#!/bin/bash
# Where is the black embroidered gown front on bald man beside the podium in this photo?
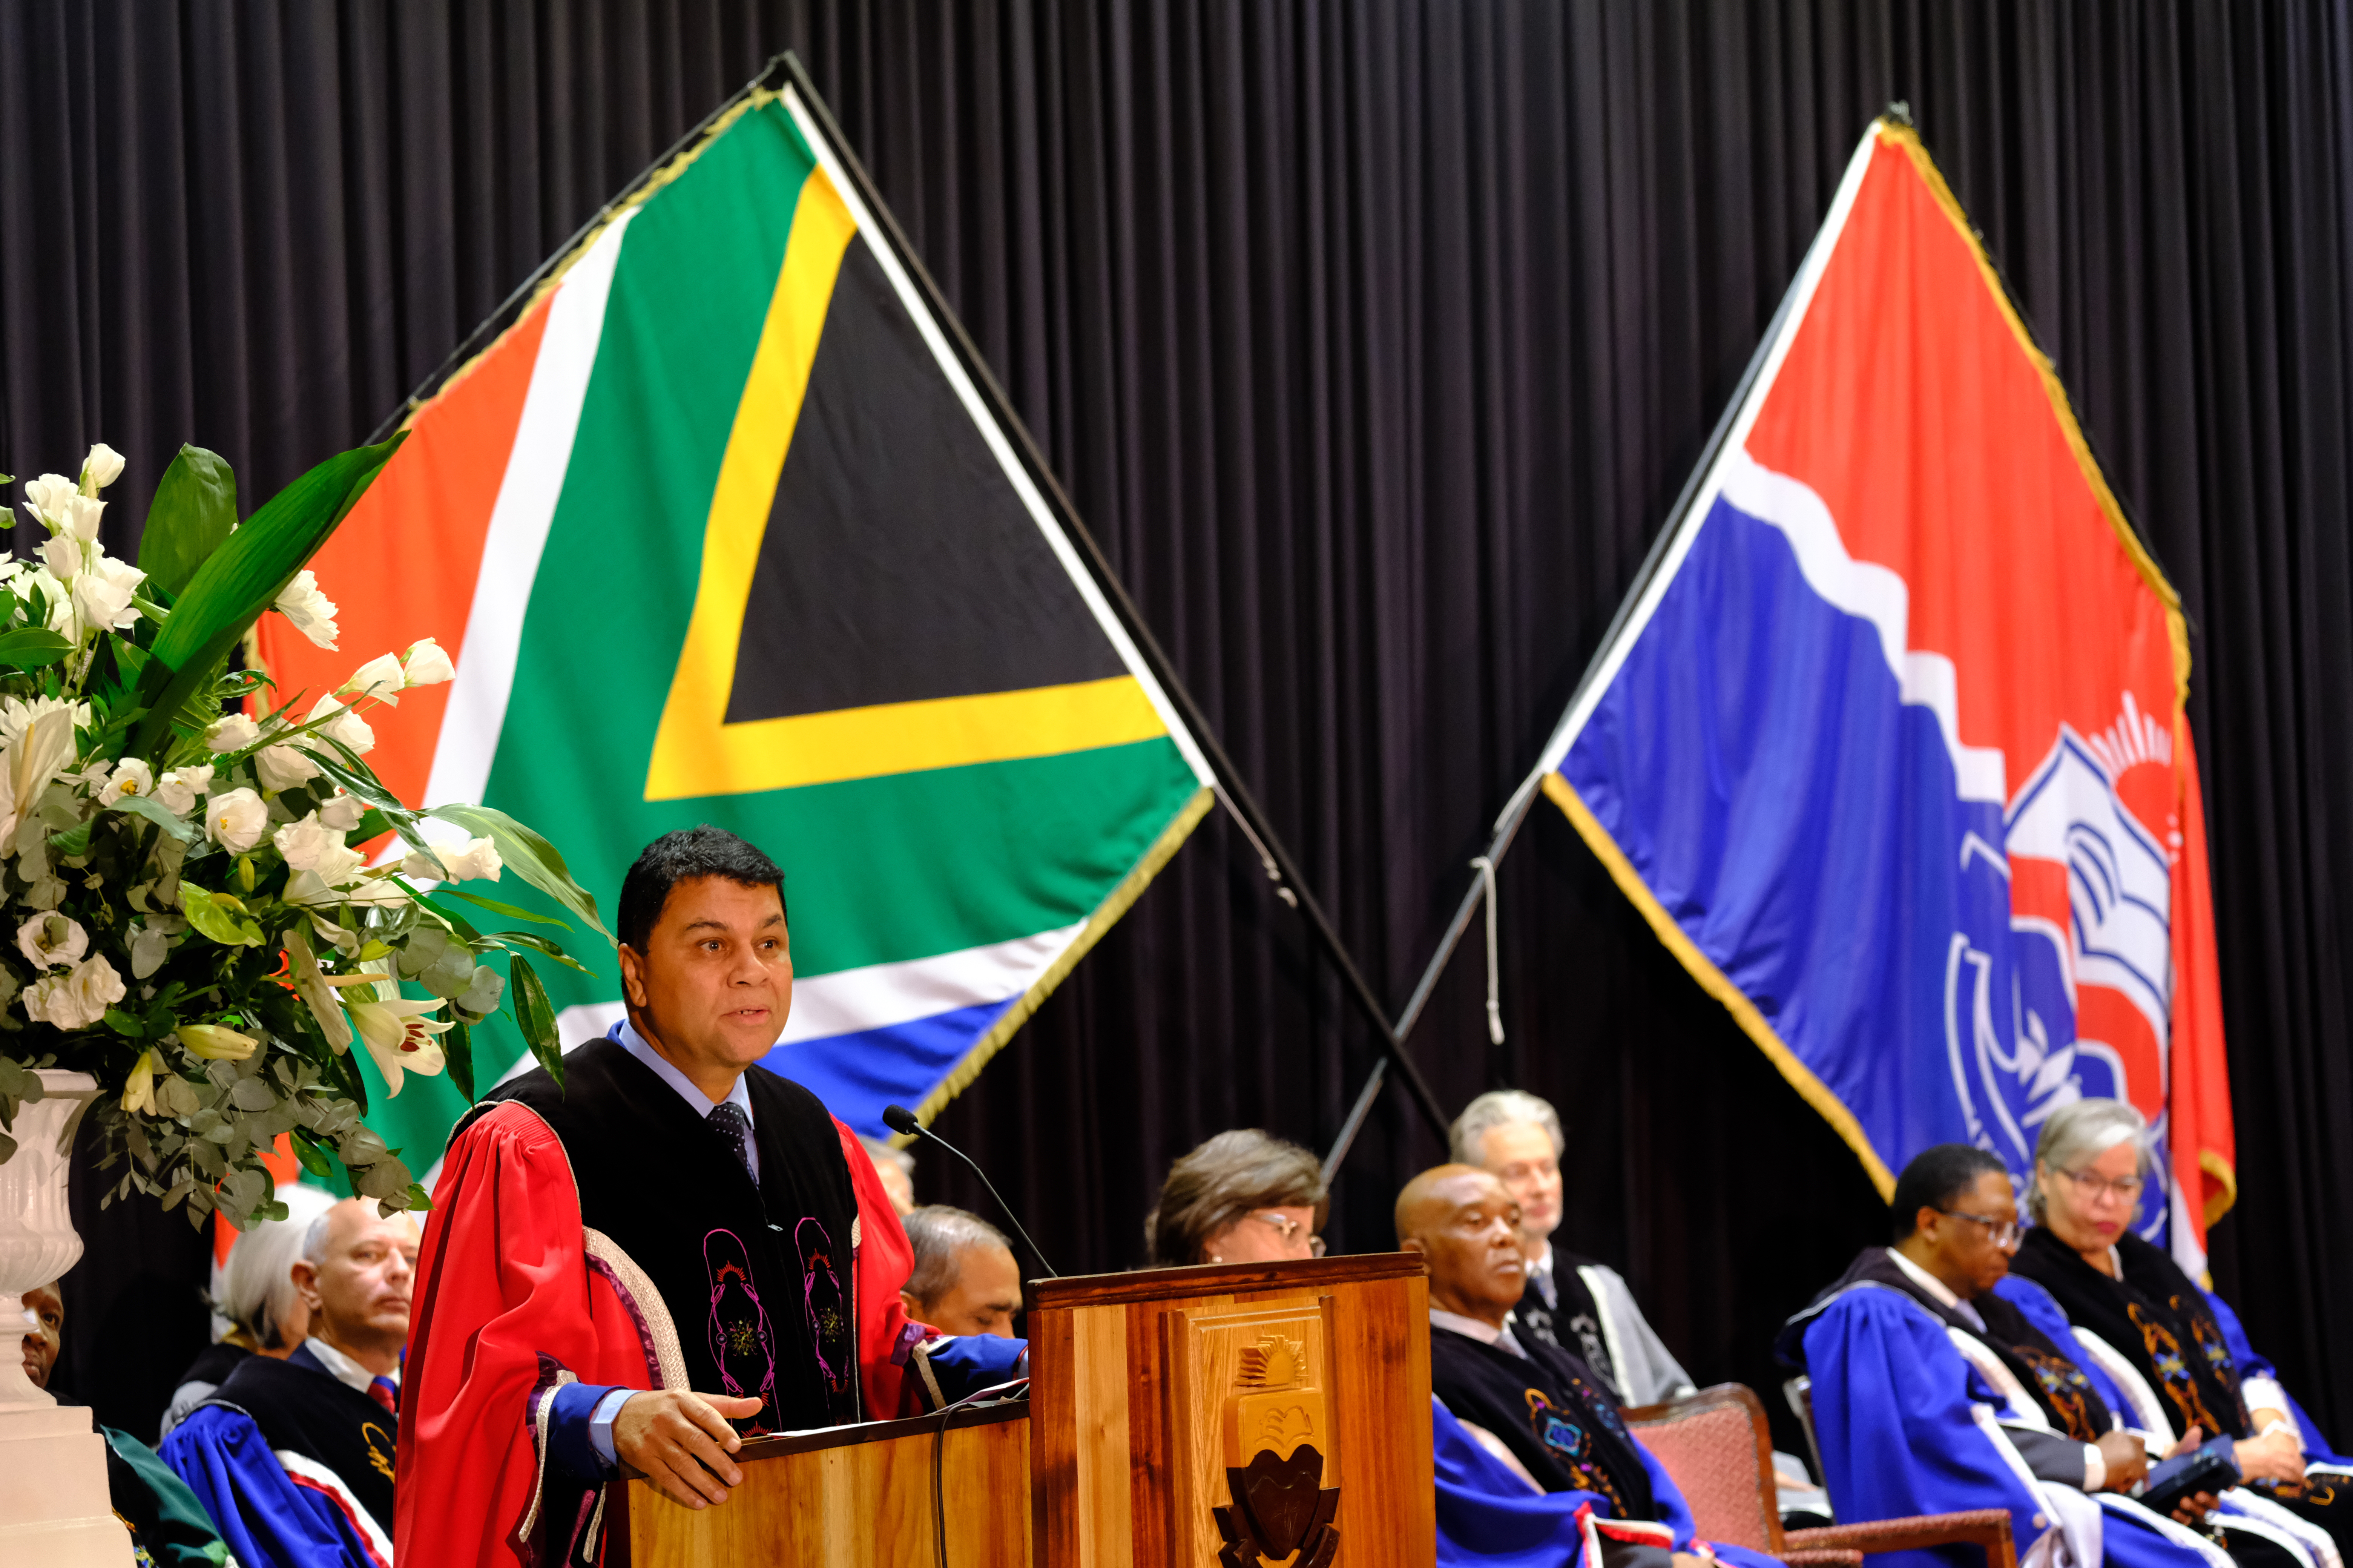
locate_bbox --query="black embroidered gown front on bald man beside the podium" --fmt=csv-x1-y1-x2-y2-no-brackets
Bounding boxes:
1431,1323,1659,1519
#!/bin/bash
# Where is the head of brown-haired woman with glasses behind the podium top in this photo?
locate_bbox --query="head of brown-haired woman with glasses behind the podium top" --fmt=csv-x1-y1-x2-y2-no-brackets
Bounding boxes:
1144,1128,1332,1269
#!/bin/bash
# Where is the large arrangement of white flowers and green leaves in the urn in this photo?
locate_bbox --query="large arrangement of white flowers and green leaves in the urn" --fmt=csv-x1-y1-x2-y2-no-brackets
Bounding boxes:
0,438,609,1227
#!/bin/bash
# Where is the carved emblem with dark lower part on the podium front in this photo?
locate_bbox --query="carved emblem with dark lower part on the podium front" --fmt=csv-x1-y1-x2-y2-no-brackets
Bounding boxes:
1212,1333,1339,1568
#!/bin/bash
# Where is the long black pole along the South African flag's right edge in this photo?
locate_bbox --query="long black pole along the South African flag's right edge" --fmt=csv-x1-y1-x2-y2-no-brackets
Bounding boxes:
772,49,1447,1140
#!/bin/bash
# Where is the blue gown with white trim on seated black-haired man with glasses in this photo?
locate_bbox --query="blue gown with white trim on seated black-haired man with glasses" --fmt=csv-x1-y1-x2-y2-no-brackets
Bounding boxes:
1802,1283,2231,1568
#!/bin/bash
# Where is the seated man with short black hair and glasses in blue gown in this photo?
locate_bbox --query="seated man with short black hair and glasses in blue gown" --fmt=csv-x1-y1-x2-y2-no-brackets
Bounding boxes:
1776,1144,2275,1568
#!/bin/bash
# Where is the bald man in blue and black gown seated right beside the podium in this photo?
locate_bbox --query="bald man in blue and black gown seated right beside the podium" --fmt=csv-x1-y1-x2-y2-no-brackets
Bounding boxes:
1398,1165,1774,1568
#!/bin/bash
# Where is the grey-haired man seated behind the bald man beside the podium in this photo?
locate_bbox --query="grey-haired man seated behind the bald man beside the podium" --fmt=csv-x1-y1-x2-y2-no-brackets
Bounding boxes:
1452,1090,1692,1405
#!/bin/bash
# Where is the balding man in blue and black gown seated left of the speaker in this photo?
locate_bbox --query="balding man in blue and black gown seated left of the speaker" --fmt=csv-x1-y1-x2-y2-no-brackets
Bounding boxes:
163,1198,416,1568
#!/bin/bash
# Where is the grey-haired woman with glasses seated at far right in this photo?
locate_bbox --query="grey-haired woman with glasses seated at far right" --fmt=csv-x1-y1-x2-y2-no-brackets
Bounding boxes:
2012,1100,2353,1556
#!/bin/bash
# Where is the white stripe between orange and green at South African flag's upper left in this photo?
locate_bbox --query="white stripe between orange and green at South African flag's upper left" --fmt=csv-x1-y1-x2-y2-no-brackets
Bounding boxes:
426,207,640,805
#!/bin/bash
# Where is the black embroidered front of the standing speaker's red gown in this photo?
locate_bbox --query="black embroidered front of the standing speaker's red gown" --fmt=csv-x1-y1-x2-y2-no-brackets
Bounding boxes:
482,1038,861,1436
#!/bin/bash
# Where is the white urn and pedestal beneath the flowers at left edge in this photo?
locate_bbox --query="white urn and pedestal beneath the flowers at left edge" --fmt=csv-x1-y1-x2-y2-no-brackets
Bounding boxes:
0,1071,132,1568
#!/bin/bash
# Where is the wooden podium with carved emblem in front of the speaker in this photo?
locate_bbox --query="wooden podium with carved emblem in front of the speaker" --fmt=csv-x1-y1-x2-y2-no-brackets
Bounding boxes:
607,1252,1438,1568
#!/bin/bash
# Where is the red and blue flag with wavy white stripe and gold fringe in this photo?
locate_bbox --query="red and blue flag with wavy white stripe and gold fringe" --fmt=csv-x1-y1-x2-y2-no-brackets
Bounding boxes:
1539,123,2235,1267
